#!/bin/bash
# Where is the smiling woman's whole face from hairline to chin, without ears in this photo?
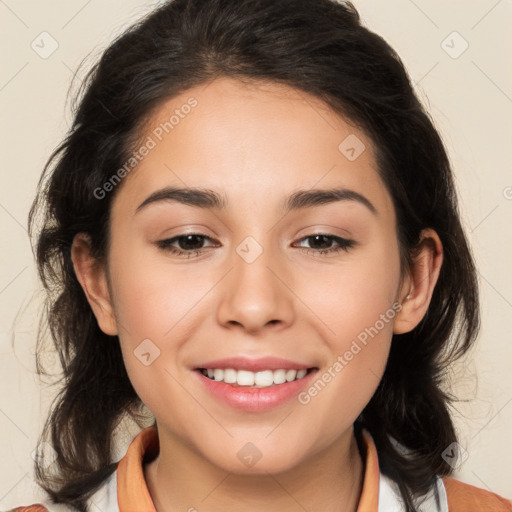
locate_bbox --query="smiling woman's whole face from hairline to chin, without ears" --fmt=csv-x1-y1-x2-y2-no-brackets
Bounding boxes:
88,78,408,472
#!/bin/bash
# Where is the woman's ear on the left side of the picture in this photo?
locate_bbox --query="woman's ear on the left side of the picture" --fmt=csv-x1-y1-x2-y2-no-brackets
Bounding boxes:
71,233,118,336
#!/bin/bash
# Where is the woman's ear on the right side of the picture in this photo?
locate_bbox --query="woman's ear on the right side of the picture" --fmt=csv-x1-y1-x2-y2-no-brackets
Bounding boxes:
393,229,443,334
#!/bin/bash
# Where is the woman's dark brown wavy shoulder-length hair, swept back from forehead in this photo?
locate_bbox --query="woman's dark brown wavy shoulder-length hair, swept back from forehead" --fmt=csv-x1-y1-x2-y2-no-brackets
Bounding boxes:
29,0,479,512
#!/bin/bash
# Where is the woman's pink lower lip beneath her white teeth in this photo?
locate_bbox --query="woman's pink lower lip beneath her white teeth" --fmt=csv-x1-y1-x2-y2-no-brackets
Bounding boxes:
195,369,318,412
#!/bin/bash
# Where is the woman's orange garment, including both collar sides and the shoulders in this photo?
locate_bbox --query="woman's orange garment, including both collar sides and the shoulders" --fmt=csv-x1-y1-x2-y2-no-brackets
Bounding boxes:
9,427,512,512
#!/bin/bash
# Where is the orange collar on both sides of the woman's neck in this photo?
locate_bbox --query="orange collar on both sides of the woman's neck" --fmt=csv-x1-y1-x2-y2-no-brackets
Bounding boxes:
117,427,380,512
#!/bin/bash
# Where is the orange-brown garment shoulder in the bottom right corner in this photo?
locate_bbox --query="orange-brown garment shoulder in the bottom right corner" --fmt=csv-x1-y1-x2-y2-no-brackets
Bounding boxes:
443,477,512,512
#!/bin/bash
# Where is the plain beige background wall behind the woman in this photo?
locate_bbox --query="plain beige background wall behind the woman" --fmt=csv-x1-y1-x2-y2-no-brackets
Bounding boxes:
0,0,512,510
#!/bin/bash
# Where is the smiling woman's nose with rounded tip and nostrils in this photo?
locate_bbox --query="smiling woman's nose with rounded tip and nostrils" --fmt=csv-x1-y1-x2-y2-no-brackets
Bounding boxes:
218,242,294,334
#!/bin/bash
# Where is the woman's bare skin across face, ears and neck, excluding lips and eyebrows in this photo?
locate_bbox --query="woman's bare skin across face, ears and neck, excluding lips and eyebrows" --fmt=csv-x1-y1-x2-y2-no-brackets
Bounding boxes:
72,78,442,512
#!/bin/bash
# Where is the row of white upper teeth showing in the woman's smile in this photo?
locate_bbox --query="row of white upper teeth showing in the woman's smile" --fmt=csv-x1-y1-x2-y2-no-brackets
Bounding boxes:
201,368,308,388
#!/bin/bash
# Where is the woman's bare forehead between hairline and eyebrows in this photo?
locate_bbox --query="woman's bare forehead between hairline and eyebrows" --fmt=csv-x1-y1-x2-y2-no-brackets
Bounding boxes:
111,78,391,217
